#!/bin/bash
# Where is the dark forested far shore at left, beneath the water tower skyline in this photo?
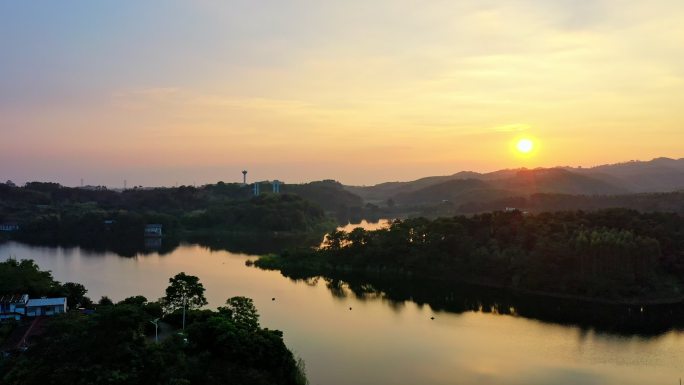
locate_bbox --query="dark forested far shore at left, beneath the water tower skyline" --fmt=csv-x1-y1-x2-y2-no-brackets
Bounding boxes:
0,182,343,247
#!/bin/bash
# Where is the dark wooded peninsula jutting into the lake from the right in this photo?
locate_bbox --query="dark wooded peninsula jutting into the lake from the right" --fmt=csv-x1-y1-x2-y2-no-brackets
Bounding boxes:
257,209,684,299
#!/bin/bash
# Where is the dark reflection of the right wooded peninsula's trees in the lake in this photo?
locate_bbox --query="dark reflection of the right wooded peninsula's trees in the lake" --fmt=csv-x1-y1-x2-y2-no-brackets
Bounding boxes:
276,270,684,337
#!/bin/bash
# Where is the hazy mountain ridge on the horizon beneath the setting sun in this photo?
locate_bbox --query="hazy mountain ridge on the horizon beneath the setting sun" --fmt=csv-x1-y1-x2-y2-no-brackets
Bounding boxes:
345,158,684,205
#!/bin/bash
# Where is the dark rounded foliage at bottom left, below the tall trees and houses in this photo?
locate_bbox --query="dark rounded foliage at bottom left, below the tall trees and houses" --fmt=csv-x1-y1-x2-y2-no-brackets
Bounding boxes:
0,303,305,385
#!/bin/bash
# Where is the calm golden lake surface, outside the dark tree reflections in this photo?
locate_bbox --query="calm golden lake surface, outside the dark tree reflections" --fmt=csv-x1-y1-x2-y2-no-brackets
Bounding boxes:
0,226,684,385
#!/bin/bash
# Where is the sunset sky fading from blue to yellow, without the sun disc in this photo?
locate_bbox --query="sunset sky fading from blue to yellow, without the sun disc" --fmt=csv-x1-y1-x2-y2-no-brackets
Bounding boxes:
0,0,684,187
